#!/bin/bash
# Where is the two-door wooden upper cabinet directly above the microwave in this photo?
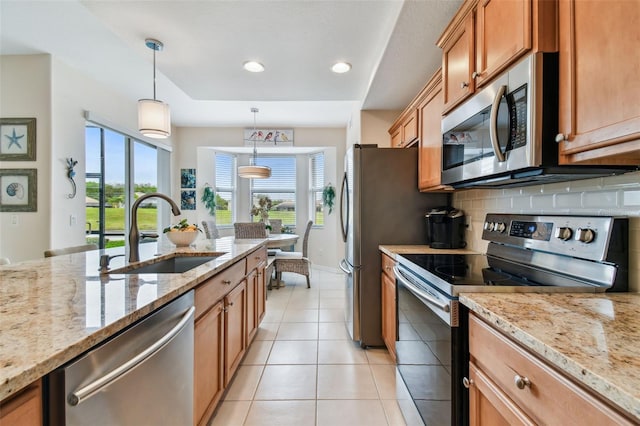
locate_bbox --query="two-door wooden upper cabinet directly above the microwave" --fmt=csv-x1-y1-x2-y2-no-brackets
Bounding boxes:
437,0,557,113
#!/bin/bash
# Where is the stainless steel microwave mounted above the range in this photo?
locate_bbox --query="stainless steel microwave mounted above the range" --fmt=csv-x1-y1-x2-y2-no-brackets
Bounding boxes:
442,53,636,188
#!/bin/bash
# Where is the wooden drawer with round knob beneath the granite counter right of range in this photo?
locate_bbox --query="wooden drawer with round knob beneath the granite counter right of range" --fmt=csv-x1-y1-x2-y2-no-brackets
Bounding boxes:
469,315,632,425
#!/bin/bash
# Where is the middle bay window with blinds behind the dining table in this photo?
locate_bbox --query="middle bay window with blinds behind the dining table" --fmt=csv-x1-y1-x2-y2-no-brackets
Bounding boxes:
251,155,296,226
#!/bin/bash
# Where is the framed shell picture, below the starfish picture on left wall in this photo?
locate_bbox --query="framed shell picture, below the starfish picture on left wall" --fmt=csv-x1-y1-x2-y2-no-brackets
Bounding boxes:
0,169,38,212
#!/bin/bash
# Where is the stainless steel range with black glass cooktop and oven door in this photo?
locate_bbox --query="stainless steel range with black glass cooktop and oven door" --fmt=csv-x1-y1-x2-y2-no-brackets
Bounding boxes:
394,214,629,425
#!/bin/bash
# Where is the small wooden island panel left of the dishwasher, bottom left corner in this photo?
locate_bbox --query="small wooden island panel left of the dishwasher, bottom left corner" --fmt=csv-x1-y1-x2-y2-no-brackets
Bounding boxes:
0,379,43,426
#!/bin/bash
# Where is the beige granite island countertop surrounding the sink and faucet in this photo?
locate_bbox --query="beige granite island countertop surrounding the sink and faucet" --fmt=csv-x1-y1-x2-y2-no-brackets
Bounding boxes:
0,237,265,400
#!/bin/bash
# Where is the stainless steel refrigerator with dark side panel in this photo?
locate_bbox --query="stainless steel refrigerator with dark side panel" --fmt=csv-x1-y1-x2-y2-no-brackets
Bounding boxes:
340,145,449,347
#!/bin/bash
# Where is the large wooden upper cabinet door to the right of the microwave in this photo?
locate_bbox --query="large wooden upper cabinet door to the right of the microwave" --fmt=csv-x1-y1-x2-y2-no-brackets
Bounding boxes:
558,0,640,164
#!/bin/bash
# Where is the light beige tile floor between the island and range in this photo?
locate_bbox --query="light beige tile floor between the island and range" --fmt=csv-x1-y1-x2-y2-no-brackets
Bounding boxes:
210,269,422,426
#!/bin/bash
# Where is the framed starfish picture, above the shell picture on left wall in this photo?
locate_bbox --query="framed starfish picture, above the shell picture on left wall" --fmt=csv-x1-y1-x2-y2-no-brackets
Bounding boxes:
0,118,36,161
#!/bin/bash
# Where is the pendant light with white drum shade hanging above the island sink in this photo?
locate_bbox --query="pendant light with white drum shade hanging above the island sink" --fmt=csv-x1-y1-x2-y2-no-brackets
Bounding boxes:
138,38,171,139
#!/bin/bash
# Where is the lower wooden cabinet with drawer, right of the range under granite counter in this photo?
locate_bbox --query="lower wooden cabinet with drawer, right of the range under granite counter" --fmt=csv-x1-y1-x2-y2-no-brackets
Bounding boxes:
467,315,634,426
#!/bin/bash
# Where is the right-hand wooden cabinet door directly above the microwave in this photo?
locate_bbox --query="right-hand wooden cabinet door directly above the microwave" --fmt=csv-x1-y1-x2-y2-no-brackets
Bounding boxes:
474,0,531,87
